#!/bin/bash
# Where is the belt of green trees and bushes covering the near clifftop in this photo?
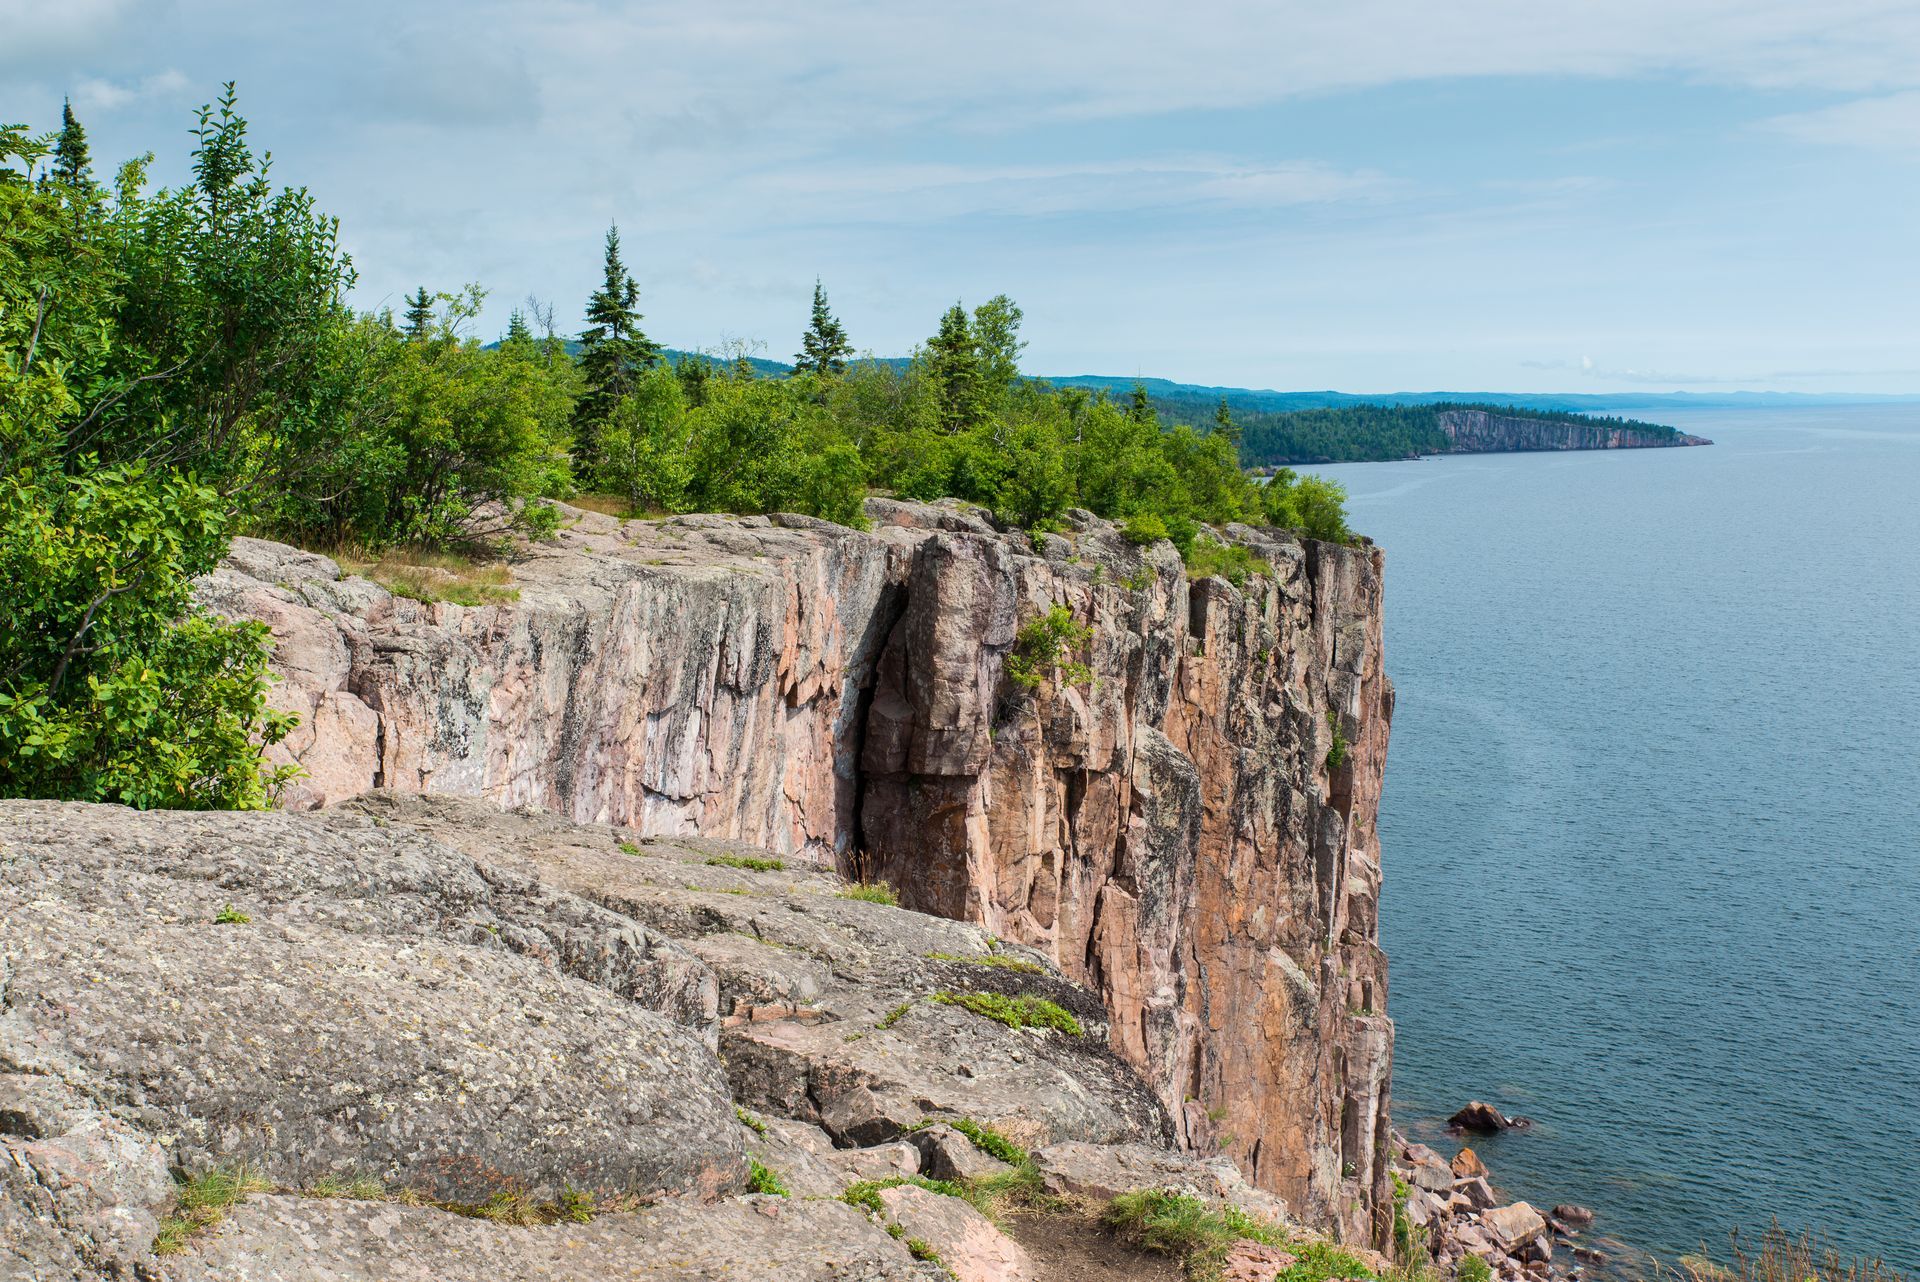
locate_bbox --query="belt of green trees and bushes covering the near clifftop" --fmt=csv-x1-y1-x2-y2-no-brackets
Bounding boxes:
0,86,1350,808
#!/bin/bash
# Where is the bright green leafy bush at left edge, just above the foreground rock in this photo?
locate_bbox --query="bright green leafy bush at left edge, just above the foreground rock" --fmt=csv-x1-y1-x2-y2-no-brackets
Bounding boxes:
0,463,294,810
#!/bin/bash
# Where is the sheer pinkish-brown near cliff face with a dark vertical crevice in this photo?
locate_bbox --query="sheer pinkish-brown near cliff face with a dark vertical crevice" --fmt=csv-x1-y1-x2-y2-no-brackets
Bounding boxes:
202,501,1392,1242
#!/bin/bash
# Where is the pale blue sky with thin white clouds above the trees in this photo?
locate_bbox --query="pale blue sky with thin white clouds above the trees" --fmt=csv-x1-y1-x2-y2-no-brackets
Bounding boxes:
0,0,1920,392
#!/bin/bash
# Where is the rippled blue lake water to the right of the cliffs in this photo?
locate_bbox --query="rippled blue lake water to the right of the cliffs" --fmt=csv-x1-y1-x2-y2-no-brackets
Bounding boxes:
1315,407,1920,1270
